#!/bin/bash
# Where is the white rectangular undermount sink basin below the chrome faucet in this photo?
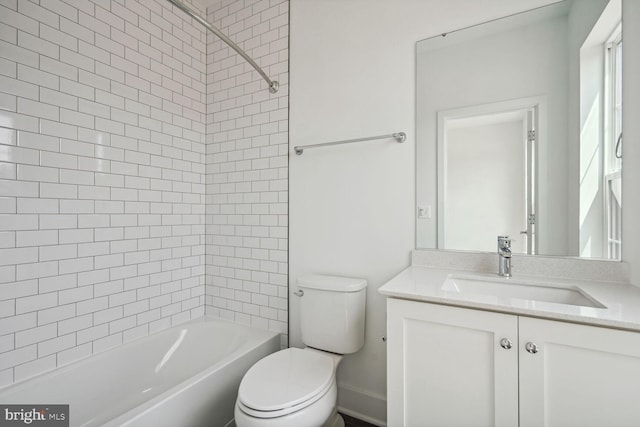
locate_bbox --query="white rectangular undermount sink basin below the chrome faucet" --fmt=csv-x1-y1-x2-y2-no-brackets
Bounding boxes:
441,275,606,308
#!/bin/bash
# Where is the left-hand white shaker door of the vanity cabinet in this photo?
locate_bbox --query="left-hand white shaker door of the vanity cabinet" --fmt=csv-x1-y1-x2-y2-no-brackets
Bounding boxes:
387,298,518,427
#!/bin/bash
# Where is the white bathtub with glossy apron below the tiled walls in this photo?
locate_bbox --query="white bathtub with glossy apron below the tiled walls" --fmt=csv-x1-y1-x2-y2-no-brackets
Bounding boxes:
0,318,280,427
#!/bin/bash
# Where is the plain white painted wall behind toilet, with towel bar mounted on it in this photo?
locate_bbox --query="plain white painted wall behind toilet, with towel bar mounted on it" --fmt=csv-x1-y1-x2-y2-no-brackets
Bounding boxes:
289,0,549,422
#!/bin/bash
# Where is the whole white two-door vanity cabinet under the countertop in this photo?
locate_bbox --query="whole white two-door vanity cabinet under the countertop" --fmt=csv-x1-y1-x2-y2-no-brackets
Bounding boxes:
387,298,640,427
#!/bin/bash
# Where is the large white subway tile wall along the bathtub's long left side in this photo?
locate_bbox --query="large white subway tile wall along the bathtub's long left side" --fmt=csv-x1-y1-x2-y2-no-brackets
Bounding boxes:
0,0,206,386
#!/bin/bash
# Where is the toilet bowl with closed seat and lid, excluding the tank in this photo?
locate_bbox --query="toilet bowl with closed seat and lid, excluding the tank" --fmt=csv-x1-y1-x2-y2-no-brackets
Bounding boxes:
235,348,344,427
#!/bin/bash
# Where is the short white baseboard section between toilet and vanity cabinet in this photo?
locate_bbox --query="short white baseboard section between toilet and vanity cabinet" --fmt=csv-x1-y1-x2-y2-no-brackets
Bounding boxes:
338,384,387,427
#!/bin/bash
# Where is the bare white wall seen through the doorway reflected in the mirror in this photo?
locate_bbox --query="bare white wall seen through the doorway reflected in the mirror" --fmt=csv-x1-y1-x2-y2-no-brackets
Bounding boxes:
440,118,527,253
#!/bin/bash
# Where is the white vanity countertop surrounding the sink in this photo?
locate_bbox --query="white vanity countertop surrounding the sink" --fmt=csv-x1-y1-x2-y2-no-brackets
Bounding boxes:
378,265,640,331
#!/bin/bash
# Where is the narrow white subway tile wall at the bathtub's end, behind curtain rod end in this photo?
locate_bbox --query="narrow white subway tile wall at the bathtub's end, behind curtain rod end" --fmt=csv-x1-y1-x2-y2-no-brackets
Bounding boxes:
206,0,289,346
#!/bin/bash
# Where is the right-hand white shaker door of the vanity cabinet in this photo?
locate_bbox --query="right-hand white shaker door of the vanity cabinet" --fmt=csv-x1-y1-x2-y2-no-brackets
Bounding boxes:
519,317,640,427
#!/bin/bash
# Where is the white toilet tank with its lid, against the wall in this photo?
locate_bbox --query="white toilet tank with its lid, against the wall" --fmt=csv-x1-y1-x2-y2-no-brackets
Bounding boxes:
298,275,367,354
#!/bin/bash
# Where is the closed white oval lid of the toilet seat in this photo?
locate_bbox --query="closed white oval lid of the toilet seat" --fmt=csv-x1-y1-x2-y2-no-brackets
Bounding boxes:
238,348,334,411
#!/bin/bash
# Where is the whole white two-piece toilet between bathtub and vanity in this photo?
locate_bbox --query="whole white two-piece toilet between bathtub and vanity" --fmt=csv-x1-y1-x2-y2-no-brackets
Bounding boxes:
235,275,367,427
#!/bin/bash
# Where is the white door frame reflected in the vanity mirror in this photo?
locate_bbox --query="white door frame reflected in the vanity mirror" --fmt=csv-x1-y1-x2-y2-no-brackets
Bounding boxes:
436,96,546,254
